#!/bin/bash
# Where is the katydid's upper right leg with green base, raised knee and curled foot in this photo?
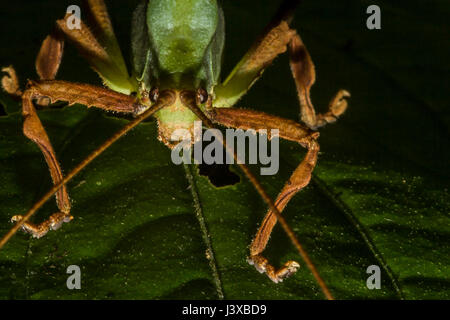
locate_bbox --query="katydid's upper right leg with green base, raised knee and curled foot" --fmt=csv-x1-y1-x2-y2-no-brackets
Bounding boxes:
213,2,350,129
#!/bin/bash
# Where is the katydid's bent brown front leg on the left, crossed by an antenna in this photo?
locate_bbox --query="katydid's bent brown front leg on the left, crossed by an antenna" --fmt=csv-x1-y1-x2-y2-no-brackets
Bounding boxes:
2,80,145,238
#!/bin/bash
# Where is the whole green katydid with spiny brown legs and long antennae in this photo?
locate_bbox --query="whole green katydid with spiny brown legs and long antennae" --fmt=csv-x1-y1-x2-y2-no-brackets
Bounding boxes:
0,0,350,299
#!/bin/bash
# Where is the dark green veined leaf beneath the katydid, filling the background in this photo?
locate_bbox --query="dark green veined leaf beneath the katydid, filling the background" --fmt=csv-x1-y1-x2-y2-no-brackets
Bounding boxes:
0,0,450,299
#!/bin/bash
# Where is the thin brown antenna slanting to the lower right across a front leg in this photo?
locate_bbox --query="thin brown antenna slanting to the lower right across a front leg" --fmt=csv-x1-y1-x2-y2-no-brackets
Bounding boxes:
182,95,334,300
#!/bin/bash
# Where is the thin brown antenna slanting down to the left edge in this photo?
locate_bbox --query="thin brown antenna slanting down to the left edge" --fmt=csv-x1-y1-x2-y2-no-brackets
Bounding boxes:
0,93,173,249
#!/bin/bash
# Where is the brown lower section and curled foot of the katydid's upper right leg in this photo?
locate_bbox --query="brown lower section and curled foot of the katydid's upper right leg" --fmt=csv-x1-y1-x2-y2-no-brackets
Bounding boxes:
288,30,350,129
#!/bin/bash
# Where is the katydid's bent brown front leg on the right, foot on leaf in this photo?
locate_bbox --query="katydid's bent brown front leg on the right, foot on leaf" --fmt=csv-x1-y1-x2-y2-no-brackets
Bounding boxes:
208,108,319,283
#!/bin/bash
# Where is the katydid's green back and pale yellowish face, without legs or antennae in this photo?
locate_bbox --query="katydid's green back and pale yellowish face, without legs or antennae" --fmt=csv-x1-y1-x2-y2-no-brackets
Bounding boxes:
132,0,225,146
